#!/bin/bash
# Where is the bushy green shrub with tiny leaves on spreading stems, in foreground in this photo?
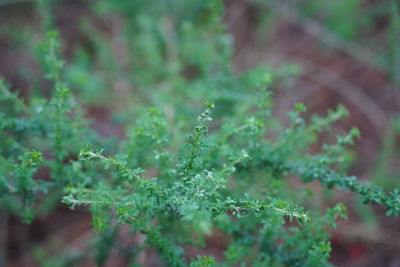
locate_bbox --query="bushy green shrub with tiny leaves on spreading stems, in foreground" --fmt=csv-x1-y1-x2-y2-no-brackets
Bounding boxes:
0,1,400,266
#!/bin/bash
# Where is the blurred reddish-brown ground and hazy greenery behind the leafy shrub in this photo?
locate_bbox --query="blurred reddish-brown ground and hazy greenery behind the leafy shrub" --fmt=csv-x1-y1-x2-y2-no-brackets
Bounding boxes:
0,0,400,267
